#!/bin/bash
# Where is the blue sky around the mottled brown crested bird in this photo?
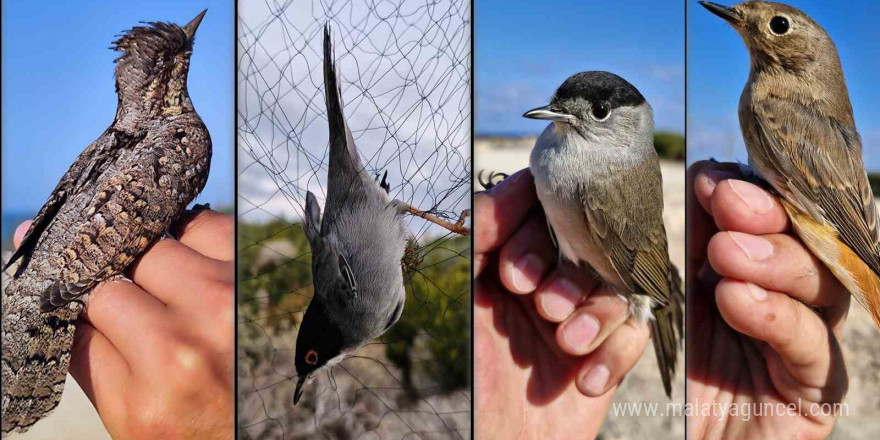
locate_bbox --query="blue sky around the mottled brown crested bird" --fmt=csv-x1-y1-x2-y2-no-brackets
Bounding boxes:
2,0,235,212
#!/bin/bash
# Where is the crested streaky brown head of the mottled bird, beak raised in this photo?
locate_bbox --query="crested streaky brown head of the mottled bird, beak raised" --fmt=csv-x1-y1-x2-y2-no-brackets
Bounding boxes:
111,10,208,115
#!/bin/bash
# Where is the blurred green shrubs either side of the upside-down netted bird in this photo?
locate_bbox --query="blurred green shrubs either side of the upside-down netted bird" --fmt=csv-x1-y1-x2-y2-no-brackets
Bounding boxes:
238,221,471,393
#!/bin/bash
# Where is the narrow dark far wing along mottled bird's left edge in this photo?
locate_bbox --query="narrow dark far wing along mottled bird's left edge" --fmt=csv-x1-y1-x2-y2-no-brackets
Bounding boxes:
3,130,129,274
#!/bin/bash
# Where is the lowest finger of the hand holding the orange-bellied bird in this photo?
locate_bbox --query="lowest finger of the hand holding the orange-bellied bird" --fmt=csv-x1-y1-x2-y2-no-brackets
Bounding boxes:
715,278,831,396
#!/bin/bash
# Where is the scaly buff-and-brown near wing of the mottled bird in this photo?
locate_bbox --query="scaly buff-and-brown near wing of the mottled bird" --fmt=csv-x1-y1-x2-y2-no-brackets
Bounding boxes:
41,146,187,310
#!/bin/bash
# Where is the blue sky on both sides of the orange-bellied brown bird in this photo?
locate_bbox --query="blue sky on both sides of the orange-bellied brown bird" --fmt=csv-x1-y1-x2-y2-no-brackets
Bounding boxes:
687,1,880,171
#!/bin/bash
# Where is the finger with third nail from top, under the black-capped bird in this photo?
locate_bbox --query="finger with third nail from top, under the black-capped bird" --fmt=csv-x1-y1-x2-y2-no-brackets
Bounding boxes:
556,287,629,356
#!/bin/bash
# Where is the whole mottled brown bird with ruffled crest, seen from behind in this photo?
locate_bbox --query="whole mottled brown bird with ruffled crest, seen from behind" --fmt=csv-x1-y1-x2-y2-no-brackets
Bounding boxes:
2,11,211,433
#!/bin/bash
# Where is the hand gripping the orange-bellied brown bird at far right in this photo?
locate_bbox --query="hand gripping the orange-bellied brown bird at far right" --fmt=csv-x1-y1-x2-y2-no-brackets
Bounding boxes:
686,161,850,439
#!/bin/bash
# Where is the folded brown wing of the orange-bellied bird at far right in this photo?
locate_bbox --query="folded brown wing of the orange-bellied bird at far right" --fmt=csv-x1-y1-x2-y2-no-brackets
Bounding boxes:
742,98,880,274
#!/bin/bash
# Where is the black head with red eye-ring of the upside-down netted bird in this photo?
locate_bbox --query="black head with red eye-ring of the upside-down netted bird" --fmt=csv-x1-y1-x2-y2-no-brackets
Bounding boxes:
293,297,345,404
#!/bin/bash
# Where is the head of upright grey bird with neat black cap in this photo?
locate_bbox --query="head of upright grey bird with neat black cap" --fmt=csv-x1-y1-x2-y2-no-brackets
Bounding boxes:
523,71,653,140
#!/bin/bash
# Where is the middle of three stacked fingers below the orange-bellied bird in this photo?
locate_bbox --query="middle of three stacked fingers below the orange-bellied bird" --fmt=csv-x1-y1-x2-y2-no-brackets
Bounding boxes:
709,232,849,307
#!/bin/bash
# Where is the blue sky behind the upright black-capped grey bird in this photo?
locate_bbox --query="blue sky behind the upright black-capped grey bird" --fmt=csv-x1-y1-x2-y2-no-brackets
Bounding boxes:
474,0,684,135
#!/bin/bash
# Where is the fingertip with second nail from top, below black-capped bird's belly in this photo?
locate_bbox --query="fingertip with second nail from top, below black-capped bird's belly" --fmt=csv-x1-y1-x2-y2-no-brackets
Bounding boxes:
535,264,596,322
